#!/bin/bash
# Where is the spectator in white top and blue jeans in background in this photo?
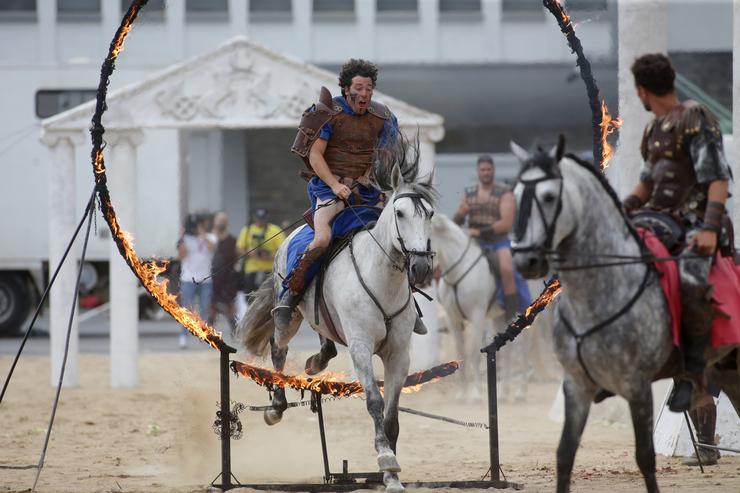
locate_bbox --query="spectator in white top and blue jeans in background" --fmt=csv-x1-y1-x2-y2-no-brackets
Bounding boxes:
177,214,217,349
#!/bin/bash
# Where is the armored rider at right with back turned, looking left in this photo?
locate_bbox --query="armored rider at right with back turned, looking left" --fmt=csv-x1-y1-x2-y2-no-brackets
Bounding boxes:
623,54,731,412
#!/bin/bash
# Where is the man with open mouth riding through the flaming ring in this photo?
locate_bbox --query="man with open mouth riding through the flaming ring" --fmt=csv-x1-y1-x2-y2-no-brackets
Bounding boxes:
272,59,426,334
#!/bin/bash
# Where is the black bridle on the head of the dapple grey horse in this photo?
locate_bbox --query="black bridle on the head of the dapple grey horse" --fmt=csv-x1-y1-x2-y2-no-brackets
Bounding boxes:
511,164,563,254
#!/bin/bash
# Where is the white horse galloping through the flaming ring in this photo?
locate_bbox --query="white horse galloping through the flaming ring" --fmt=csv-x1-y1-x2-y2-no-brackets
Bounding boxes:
238,139,435,493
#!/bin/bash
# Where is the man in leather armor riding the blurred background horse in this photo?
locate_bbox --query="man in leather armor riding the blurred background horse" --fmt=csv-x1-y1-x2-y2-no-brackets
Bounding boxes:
453,155,529,321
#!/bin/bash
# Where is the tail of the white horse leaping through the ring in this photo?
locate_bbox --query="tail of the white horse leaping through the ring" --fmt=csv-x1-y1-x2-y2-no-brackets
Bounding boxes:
236,274,275,356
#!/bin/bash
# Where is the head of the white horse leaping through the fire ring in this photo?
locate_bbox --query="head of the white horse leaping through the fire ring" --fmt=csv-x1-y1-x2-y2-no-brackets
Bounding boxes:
374,135,437,285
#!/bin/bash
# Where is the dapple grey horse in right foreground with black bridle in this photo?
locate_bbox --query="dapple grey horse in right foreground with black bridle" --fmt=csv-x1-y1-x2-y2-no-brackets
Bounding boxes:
511,140,740,492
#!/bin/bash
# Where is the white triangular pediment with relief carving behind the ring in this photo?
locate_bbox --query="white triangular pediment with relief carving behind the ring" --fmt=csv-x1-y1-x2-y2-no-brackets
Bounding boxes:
43,37,444,141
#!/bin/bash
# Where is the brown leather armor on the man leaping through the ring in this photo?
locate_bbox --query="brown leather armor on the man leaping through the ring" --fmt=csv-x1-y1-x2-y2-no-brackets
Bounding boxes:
291,87,392,179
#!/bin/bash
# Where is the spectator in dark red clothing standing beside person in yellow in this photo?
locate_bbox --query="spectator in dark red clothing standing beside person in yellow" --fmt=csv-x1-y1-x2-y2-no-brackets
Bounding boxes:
209,212,238,332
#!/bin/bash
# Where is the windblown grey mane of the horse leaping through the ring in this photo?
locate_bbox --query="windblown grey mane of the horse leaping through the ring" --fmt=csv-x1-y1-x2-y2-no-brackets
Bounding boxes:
370,132,439,214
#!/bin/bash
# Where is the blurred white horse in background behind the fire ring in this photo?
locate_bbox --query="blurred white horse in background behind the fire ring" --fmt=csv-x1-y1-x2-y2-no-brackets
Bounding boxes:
432,214,503,400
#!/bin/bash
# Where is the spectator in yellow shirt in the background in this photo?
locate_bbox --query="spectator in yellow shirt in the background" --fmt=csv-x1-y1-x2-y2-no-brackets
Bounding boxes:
236,208,285,293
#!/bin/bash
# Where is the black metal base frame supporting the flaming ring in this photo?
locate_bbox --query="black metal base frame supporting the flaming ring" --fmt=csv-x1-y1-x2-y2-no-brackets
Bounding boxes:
211,348,524,493
